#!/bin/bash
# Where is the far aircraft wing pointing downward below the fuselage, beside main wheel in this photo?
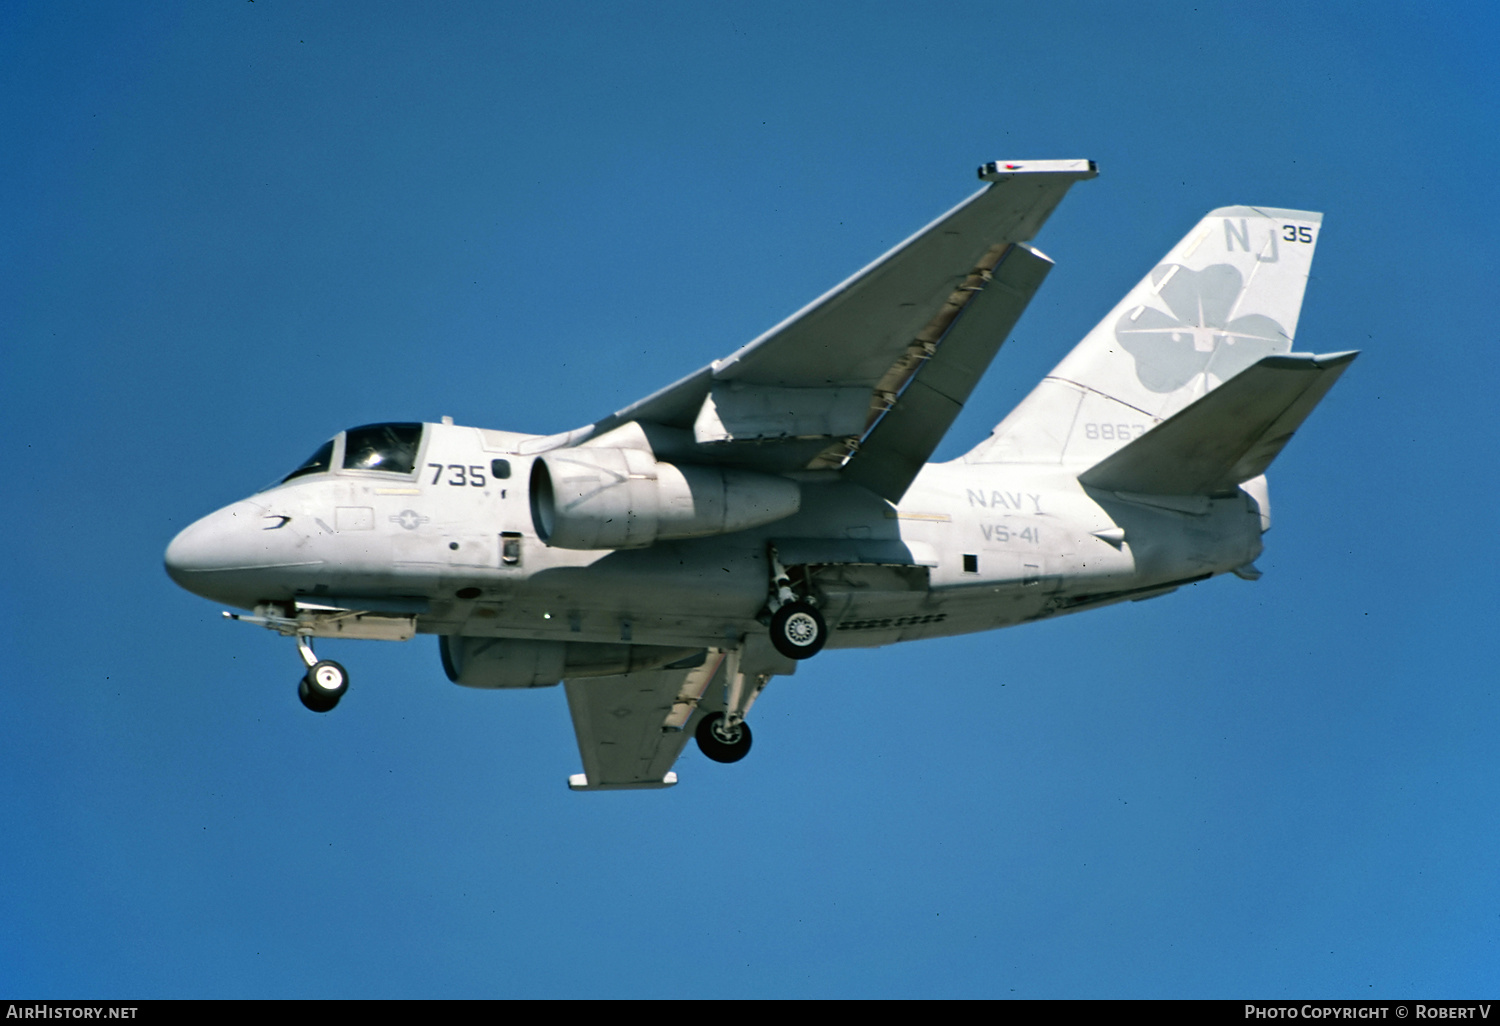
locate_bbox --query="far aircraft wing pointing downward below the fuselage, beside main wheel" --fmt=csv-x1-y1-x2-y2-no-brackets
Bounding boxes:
564,648,725,791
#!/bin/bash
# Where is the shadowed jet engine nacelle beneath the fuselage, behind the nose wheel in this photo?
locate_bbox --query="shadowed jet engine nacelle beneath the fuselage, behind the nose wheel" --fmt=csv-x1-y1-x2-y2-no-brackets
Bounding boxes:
438,635,704,687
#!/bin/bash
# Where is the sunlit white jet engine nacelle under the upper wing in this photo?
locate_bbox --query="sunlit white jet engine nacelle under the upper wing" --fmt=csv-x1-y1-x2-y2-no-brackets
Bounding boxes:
531,447,803,549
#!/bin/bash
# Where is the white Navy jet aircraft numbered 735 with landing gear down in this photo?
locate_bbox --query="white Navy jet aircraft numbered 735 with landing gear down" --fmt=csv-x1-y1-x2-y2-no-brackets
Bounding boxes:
167,161,1356,791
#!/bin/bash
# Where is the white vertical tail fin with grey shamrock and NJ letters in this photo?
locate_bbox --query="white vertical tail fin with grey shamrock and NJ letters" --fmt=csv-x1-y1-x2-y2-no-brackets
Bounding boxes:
965,207,1323,465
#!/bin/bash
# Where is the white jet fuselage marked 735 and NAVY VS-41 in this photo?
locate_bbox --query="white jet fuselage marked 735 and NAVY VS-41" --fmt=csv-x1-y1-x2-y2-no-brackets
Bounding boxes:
167,423,1265,648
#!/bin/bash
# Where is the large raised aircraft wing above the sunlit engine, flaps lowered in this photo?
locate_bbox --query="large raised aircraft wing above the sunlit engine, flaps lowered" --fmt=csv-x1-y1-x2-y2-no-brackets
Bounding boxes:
561,161,1097,501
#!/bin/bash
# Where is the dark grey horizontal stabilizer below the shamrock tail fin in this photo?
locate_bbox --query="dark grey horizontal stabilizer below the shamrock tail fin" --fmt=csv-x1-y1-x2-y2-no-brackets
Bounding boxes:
1079,353,1359,495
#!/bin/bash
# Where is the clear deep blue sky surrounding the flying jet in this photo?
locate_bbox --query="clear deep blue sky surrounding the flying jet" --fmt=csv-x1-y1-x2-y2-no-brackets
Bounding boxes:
0,0,1500,998
